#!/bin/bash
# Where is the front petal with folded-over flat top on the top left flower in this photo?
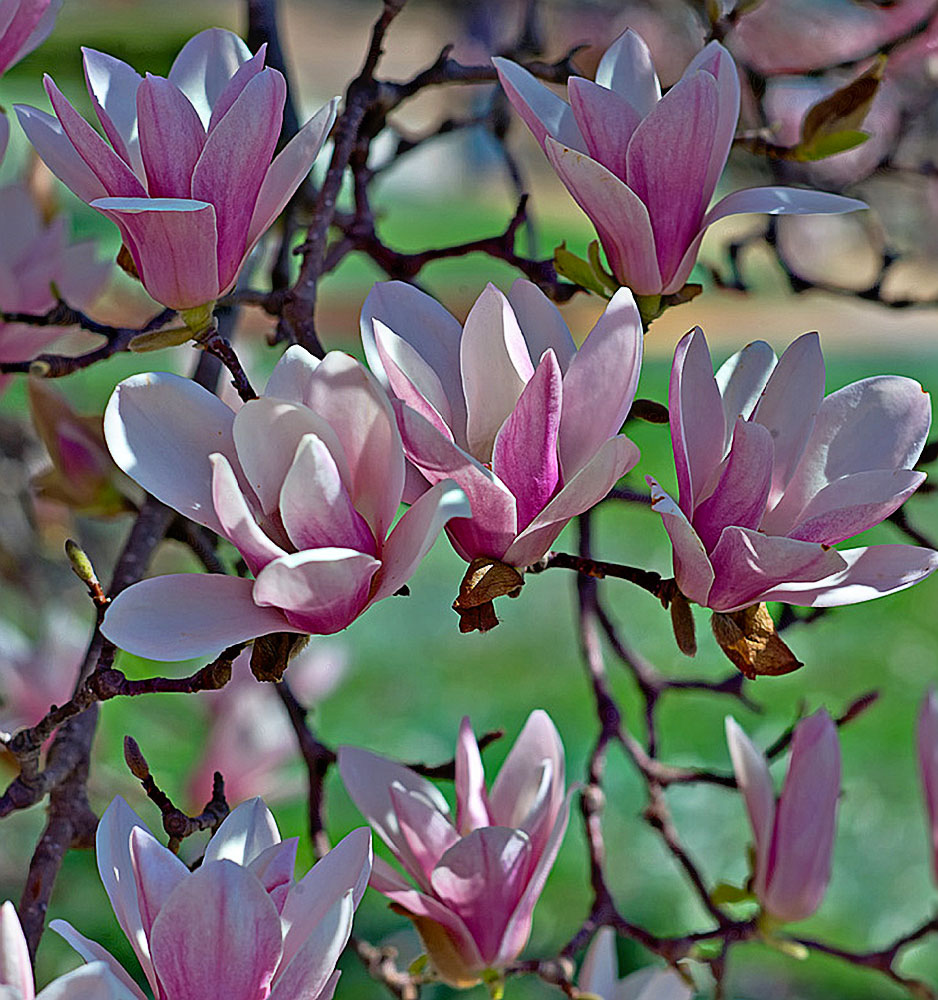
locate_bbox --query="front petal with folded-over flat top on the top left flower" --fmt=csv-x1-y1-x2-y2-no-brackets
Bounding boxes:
91,198,221,310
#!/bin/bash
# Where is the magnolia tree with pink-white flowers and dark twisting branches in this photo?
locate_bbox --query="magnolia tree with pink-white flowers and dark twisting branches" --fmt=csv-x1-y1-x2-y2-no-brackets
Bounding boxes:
0,0,938,1000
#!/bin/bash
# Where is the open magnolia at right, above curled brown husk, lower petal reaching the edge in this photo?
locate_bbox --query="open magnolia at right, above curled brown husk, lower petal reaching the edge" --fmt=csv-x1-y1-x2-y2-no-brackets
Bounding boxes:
648,328,938,612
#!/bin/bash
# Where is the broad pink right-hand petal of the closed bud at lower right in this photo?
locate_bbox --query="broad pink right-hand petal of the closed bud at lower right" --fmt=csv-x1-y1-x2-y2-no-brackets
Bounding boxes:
761,709,840,921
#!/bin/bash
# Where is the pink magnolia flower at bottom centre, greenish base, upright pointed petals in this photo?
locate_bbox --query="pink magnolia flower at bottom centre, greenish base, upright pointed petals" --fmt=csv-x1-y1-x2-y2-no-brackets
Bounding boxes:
339,710,570,986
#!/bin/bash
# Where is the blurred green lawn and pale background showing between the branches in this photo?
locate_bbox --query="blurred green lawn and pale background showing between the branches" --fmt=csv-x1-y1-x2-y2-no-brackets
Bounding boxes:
0,0,938,1000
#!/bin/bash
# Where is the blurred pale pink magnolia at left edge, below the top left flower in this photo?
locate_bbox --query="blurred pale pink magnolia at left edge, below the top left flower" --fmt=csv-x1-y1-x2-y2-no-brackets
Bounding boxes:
0,188,112,391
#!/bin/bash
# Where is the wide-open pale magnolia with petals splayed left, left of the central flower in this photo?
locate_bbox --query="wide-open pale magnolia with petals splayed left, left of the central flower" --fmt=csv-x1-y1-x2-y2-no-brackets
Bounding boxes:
102,347,469,660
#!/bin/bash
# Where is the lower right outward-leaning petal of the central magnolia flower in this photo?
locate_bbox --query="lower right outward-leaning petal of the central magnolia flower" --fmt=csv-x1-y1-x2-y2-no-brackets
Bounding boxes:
504,435,639,566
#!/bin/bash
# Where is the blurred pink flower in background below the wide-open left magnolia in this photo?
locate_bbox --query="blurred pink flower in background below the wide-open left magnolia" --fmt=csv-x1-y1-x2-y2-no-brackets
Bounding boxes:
189,640,348,808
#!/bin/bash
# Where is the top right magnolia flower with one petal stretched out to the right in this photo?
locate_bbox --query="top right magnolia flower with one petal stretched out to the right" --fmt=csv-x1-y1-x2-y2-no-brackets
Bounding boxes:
493,30,866,295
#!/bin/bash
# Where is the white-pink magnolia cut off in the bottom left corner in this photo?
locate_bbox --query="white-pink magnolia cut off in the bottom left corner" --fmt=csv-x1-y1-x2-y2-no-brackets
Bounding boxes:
0,900,136,1000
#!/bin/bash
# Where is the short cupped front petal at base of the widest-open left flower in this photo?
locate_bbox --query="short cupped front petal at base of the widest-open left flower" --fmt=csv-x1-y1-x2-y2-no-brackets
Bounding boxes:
253,547,381,635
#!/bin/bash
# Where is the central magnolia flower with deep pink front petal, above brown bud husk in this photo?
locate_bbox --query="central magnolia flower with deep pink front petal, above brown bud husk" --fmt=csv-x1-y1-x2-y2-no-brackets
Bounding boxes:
362,281,642,566
